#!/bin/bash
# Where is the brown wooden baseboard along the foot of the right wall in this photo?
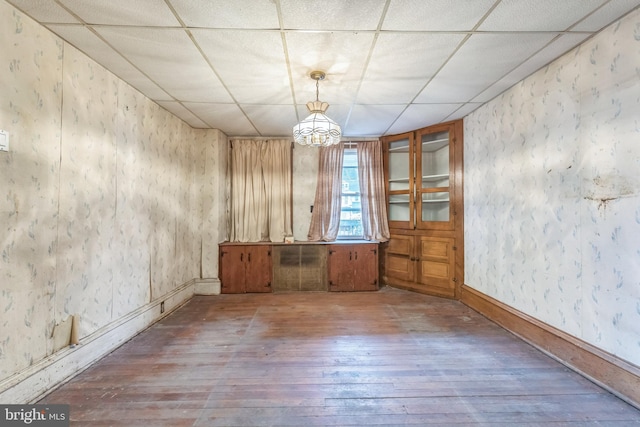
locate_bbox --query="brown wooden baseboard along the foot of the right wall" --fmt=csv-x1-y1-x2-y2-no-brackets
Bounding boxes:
460,285,640,409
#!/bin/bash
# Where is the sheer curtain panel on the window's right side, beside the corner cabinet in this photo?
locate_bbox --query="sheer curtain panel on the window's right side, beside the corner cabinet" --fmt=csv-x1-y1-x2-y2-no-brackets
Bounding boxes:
356,140,390,242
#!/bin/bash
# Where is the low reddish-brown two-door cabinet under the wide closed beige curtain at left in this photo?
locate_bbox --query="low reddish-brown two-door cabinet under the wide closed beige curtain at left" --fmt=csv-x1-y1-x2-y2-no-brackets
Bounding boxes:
219,245,271,294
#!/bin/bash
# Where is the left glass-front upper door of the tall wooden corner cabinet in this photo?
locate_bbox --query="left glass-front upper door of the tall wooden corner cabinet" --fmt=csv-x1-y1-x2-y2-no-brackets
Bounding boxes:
386,132,416,228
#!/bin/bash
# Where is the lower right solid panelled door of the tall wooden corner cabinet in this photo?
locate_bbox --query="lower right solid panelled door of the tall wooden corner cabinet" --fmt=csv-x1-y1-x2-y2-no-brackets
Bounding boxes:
418,236,455,297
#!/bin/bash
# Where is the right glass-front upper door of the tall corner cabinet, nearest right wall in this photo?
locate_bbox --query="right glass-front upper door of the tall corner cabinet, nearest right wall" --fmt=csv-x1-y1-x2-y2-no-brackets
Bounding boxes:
415,123,454,230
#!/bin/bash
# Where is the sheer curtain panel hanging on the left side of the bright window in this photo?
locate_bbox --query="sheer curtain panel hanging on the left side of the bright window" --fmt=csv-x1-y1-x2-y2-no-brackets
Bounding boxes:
307,143,344,242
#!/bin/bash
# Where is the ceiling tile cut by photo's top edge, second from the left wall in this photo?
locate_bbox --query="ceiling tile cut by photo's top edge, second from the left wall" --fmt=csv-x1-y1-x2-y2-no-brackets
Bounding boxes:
58,0,180,26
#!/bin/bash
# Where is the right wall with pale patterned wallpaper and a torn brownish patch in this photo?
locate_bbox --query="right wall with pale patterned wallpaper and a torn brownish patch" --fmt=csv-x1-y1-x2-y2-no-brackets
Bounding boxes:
464,10,640,365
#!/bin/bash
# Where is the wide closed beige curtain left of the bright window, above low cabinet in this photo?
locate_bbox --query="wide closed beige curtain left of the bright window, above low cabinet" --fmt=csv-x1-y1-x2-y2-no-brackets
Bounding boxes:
229,140,292,242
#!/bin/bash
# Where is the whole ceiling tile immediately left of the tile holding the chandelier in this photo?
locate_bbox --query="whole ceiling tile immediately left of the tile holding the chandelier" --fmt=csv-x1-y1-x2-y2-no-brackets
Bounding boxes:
192,30,293,104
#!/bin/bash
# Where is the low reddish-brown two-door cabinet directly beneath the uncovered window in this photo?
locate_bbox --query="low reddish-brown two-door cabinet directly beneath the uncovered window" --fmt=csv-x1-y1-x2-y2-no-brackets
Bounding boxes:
327,244,378,292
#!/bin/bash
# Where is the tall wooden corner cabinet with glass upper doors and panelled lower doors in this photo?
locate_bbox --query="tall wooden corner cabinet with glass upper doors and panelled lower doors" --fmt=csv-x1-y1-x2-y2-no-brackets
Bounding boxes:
383,120,464,298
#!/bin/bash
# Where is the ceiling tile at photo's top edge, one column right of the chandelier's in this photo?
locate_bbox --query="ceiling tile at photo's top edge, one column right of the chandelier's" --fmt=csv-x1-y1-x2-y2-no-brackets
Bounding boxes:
382,0,495,31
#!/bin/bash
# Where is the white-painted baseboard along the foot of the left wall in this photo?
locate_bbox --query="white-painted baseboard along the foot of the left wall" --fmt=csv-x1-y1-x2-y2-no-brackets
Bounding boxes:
0,280,195,404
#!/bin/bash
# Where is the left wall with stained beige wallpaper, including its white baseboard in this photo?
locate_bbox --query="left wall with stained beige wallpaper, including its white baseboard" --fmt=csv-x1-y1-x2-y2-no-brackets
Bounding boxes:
0,2,226,403
